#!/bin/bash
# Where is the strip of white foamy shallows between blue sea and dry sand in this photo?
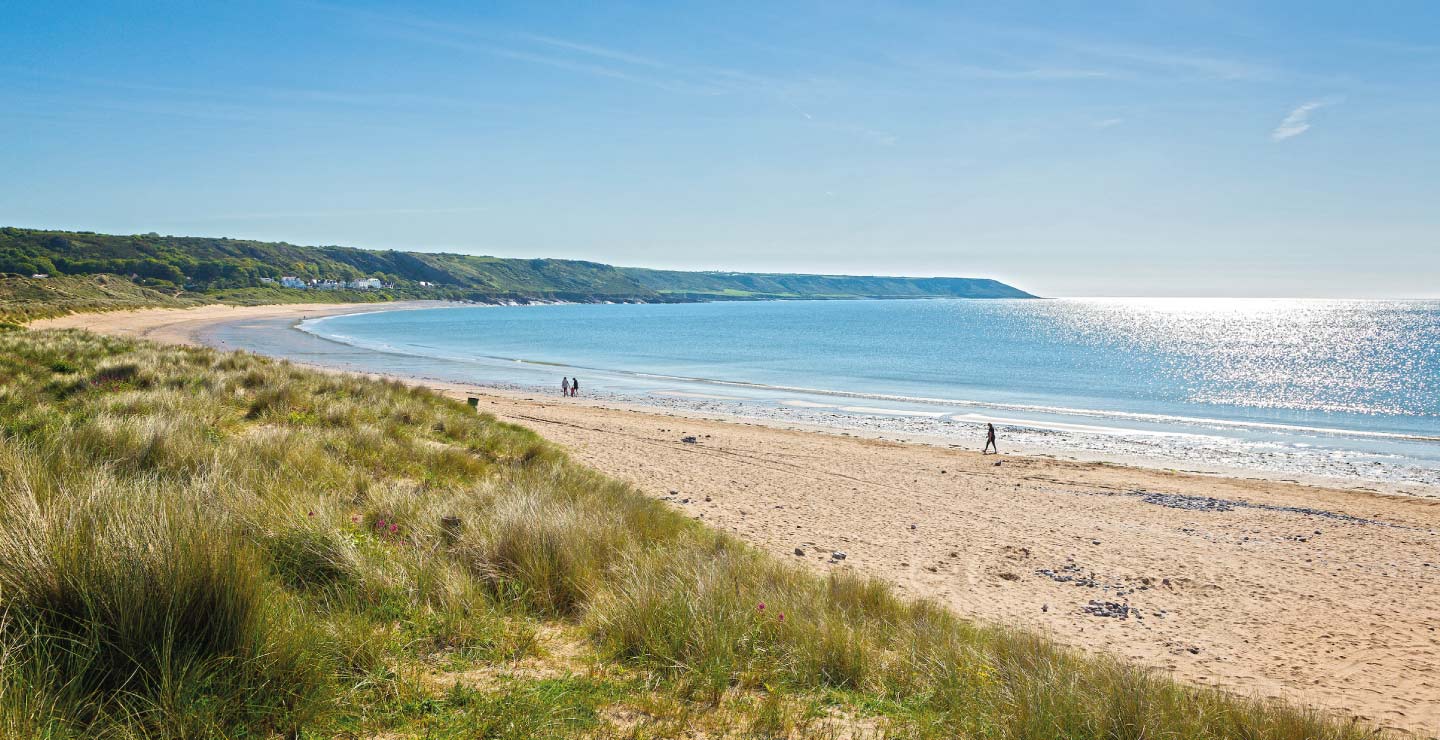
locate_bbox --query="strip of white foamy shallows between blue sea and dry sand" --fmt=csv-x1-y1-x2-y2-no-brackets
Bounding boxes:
200,308,1440,495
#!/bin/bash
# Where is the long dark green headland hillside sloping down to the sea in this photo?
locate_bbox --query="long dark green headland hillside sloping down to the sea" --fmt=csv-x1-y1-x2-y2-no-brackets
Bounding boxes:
0,227,1028,302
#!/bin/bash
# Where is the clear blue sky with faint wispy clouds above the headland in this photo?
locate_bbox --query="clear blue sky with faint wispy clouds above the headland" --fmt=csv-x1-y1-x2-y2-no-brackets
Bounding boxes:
0,0,1440,298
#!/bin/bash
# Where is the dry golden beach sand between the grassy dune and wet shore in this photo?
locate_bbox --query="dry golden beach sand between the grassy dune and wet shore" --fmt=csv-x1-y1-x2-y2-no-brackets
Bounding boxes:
33,305,1440,736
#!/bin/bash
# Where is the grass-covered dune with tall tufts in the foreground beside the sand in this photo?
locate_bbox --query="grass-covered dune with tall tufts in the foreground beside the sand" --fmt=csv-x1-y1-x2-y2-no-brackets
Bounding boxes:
0,330,1374,740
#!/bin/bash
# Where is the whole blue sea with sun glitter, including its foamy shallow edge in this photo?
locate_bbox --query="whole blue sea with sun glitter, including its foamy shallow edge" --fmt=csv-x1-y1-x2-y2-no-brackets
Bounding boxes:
200,298,1440,495
